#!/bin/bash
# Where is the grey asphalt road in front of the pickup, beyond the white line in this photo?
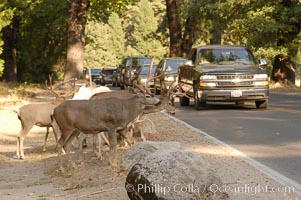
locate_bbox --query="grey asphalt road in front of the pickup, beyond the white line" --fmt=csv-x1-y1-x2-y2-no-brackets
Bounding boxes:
175,93,301,184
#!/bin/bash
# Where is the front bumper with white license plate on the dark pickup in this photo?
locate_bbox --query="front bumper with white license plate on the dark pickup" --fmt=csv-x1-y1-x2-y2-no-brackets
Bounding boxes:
198,88,269,102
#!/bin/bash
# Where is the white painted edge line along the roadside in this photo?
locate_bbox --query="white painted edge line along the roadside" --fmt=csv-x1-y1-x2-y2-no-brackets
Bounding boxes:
162,112,301,196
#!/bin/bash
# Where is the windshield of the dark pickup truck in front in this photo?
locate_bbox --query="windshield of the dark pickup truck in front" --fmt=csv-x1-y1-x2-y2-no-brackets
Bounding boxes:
198,48,256,65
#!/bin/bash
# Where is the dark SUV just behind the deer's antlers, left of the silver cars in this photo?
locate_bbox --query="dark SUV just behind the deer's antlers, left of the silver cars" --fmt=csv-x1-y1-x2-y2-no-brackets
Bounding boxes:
120,56,152,89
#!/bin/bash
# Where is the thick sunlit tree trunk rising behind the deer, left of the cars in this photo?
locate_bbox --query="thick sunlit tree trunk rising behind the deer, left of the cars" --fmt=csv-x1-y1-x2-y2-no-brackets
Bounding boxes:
64,0,90,81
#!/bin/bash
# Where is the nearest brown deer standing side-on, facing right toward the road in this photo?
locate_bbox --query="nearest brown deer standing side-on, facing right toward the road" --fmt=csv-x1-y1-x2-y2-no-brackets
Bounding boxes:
53,83,174,171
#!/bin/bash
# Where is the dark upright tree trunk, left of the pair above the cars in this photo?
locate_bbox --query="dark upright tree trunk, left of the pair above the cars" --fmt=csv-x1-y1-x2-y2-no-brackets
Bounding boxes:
166,0,183,57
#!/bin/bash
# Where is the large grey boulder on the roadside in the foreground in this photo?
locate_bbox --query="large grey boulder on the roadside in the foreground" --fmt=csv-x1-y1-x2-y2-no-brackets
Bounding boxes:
125,142,227,200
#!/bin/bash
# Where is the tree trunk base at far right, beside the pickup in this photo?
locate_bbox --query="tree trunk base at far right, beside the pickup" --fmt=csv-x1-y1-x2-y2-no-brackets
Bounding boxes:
271,54,296,85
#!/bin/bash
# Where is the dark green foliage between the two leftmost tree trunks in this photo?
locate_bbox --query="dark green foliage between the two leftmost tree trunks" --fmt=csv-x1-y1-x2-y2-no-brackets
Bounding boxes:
18,0,68,82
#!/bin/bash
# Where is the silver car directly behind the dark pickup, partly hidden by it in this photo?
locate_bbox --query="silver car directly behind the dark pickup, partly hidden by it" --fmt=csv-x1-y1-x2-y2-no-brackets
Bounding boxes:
154,57,186,94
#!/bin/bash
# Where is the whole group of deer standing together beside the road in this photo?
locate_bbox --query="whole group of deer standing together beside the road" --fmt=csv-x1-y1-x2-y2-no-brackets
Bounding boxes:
16,76,175,171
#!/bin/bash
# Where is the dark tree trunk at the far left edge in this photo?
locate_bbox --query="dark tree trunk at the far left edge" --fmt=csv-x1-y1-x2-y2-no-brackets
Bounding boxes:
3,18,19,81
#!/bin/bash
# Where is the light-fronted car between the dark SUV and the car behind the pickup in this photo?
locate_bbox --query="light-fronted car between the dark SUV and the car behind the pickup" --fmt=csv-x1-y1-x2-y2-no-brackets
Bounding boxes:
138,64,158,92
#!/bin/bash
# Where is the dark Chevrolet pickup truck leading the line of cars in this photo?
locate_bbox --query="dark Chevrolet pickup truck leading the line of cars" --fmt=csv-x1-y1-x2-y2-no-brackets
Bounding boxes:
178,45,269,109
